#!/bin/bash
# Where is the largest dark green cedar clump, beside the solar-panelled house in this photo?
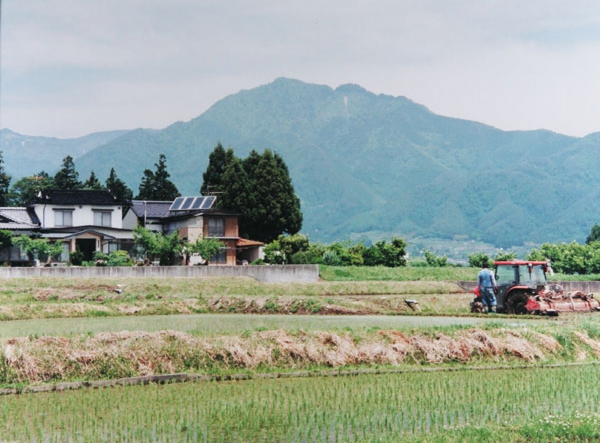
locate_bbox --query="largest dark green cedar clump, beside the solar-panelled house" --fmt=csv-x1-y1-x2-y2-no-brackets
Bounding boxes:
201,144,302,242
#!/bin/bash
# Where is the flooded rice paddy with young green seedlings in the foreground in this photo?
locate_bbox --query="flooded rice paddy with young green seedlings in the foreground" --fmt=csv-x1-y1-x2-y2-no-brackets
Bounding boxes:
0,365,600,443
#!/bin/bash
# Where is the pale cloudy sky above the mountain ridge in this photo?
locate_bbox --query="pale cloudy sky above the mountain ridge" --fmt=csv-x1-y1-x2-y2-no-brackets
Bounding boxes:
0,0,600,138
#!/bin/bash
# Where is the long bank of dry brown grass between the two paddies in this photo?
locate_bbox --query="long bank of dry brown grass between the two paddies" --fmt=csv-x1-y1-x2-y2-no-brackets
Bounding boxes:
0,329,576,384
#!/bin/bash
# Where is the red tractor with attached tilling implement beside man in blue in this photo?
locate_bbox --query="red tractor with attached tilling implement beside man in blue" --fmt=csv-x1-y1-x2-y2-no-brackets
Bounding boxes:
471,260,600,316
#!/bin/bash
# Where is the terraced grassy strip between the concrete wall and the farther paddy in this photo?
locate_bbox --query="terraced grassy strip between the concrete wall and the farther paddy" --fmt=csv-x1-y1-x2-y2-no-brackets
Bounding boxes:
0,278,470,320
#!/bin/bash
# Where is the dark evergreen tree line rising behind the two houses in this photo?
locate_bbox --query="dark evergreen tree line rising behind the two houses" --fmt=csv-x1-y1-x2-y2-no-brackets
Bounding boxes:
0,143,302,242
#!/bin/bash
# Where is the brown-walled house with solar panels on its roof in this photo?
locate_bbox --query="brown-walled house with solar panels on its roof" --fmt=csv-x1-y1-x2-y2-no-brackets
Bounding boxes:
123,196,264,265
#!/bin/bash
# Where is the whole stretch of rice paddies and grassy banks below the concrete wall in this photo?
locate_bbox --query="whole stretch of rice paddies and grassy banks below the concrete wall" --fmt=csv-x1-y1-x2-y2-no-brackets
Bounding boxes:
0,268,600,442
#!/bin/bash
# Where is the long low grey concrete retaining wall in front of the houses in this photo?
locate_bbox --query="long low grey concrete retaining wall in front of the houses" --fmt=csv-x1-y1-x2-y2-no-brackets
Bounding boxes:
0,265,319,283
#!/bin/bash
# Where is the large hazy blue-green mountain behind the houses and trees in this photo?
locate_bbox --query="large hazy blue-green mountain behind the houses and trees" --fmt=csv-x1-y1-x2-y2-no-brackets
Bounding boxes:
5,78,600,256
